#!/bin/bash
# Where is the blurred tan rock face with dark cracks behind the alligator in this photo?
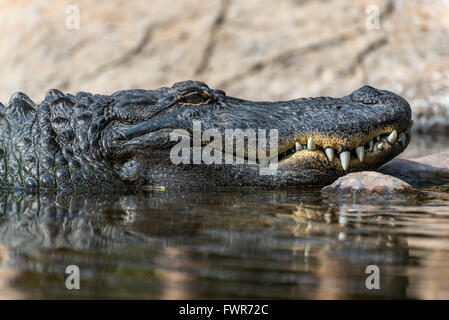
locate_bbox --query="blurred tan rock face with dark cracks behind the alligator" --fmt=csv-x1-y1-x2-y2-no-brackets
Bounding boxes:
0,0,449,134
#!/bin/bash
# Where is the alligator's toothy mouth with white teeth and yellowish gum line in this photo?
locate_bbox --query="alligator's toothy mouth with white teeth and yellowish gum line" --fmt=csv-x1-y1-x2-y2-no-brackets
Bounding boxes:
278,128,410,171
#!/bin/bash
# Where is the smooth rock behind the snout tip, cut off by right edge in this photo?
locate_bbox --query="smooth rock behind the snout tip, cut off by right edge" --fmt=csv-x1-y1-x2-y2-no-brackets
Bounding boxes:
377,152,449,187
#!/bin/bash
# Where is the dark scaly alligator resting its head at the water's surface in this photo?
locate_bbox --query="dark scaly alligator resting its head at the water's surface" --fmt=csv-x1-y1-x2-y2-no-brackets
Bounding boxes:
0,80,412,190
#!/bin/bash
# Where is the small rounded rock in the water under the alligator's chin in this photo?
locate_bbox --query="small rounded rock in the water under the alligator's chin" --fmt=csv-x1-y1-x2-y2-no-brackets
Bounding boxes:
322,171,416,200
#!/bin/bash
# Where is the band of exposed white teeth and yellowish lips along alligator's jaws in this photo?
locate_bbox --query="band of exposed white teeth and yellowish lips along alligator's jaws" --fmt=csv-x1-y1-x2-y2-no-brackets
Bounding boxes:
278,129,410,174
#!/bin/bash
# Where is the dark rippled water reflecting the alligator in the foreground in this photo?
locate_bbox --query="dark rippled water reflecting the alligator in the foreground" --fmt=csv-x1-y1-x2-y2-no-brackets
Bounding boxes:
0,136,449,299
